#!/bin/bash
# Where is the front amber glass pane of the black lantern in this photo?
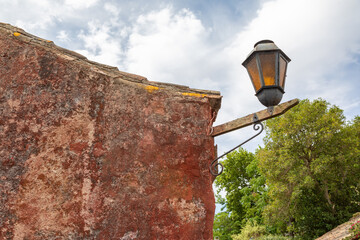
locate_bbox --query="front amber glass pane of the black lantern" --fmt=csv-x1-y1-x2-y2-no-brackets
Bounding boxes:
259,52,276,86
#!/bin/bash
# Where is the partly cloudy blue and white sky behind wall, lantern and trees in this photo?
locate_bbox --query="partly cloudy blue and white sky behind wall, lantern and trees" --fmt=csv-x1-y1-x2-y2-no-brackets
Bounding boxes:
0,0,360,210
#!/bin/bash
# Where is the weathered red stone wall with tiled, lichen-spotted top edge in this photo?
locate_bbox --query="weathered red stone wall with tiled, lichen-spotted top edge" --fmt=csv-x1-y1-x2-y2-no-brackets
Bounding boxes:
0,24,221,240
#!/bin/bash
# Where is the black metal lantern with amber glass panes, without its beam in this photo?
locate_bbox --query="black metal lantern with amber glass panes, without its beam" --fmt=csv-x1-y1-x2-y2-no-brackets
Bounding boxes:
243,40,291,107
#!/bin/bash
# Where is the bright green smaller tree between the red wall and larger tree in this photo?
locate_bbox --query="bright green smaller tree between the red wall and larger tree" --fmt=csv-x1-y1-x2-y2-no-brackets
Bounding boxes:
214,148,267,240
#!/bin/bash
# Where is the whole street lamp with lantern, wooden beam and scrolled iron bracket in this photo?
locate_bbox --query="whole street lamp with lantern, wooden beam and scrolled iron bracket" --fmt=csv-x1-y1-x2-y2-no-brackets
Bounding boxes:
210,40,292,176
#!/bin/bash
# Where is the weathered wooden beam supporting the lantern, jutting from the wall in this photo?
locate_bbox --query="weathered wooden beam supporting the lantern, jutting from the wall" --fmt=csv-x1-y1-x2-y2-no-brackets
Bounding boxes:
211,99,299,137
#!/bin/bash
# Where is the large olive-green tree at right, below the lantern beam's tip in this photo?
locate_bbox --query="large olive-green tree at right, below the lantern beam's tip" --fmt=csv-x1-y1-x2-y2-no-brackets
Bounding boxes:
257,99,360,239
